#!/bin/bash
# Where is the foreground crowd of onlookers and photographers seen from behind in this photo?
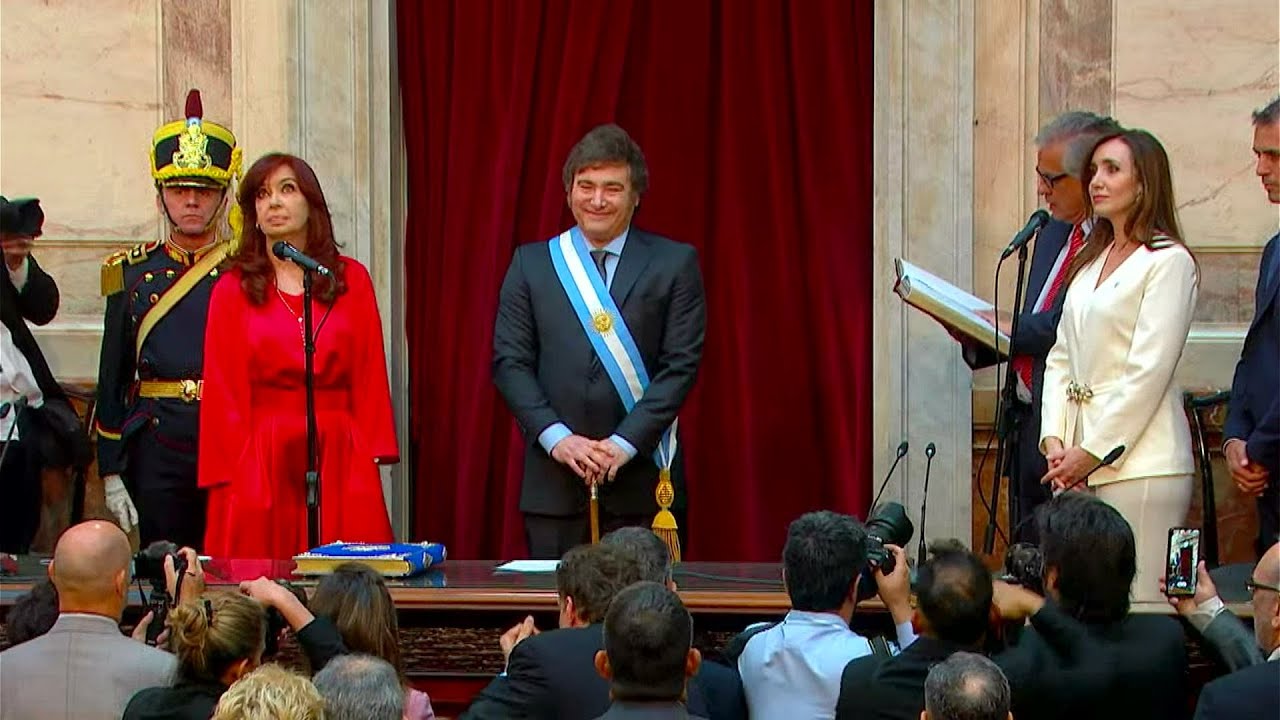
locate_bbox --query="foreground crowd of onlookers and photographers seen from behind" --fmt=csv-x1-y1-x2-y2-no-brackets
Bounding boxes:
0,493,1280,720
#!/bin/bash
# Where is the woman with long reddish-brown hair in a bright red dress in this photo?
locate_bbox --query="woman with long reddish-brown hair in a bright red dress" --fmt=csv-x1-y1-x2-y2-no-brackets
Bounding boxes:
200,154,399,559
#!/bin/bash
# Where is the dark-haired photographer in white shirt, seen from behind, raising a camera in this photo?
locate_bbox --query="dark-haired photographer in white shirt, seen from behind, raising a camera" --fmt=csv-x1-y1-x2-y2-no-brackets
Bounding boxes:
737,510,915,720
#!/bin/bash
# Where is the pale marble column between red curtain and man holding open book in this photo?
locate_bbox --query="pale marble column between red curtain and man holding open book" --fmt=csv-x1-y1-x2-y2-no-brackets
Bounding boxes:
872,0,974,552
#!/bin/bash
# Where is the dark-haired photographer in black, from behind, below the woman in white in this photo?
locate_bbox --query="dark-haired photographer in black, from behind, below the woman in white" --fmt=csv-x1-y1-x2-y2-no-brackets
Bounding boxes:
993,492,1187,720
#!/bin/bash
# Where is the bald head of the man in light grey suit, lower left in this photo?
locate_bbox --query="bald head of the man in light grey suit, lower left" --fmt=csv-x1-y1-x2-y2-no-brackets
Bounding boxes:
49,520,132,612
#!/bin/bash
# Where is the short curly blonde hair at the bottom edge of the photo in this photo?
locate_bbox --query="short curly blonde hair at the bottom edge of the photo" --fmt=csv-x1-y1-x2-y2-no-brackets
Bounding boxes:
210,664,325,720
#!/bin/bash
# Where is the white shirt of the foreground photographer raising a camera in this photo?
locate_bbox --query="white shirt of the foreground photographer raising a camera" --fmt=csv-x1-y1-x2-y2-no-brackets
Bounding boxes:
737,610,915,720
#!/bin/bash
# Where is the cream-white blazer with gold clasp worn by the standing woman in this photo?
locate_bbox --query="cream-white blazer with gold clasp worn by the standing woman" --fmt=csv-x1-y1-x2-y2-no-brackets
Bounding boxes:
1041,242,1197,486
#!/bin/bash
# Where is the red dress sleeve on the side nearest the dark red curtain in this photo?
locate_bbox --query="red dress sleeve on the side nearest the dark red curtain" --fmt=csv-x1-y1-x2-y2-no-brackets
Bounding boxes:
346,258,399,465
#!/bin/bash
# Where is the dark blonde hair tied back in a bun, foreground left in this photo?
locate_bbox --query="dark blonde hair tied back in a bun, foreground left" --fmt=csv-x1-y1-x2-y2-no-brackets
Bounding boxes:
169,591,266,683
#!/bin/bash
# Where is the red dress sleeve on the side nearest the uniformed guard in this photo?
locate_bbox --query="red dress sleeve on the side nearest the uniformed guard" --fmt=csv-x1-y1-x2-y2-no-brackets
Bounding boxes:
197,273,251,488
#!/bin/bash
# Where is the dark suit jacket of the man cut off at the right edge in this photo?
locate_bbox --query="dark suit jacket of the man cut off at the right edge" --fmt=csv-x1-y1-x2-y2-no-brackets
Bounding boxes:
1222,234,1280,483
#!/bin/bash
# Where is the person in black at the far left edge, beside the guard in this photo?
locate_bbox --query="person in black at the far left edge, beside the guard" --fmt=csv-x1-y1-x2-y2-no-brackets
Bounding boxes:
0,196,67,552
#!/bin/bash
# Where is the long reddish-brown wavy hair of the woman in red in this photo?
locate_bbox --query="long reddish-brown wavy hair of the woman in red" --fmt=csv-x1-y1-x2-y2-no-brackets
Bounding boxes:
232,152,347,305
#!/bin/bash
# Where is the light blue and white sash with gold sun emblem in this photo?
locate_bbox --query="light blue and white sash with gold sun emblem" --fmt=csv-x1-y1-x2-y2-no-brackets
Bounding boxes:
549,225,680,471
